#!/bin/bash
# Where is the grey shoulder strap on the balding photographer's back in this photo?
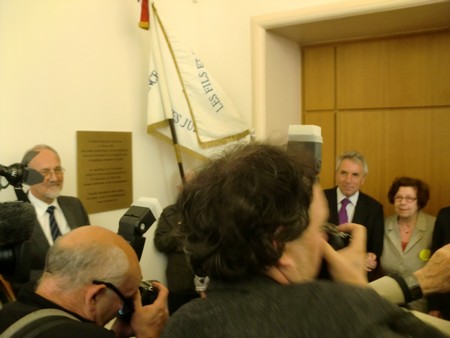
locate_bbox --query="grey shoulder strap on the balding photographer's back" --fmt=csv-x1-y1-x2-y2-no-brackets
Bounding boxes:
0,309,80,338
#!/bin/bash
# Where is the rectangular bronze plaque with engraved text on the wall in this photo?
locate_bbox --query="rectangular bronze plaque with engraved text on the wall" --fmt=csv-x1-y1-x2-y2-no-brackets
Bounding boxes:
77,131,133,214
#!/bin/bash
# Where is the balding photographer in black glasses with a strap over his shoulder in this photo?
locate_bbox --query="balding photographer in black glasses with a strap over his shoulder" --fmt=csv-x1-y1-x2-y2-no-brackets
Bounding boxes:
0,226,168,338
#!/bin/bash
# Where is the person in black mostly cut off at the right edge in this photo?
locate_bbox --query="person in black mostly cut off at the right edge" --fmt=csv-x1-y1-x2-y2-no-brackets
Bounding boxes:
428,206,450,320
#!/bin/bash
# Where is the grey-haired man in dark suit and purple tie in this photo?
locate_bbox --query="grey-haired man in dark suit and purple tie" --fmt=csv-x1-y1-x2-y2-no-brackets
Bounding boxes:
324,151,384,281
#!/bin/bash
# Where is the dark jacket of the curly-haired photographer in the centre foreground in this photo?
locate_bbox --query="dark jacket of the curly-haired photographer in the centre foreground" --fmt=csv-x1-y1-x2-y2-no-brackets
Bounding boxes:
161,276,445,338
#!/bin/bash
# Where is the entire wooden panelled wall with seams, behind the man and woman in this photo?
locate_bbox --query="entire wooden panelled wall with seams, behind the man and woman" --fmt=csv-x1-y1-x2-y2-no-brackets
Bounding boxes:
302,31,450,215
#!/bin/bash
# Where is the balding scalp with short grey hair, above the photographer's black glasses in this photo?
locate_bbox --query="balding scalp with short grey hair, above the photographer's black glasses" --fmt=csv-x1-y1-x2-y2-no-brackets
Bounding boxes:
41,226,130,291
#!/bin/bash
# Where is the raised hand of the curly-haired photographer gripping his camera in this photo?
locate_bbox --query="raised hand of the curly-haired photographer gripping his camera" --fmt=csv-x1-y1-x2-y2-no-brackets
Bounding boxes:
324,223,368,286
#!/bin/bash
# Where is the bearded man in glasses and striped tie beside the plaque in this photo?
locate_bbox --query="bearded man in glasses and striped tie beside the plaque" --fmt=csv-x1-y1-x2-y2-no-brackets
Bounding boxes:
24,145,90,283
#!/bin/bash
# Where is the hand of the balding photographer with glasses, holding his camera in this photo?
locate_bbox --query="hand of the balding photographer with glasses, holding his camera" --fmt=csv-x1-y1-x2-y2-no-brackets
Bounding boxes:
112,281,169,338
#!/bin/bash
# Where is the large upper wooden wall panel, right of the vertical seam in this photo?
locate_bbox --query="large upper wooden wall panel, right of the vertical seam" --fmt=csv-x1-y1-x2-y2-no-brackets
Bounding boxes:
336,31,450,109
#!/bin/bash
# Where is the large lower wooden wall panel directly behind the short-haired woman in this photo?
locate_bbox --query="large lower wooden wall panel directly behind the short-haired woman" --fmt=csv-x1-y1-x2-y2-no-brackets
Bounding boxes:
336,108,450,215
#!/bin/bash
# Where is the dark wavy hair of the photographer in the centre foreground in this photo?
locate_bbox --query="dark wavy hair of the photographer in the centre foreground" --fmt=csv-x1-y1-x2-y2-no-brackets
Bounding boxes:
177,143,315,281
